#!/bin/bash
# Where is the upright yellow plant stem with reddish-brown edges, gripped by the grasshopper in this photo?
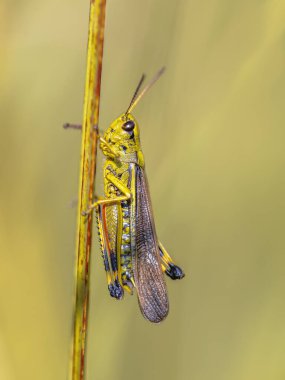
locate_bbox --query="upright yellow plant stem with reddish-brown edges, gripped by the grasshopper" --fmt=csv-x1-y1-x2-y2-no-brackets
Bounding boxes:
71,0,106,380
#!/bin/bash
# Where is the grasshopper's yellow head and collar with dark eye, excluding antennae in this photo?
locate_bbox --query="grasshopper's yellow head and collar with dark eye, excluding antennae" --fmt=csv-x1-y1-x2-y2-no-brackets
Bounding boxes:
100,113,143,166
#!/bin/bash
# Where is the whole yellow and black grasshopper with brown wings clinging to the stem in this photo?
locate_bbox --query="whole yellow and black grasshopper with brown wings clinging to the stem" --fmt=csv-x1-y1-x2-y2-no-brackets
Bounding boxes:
84,69,184,323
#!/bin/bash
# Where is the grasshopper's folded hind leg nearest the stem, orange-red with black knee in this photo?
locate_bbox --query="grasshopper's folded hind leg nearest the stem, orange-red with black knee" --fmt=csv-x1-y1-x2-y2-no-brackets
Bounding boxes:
96,205,124,300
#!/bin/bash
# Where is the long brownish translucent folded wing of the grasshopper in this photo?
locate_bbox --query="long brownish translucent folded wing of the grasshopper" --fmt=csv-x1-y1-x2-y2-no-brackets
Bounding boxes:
134,167,169,323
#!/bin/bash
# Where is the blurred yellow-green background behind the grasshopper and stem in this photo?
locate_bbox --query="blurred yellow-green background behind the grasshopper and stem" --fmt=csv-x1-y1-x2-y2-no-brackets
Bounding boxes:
0,0,285,380
